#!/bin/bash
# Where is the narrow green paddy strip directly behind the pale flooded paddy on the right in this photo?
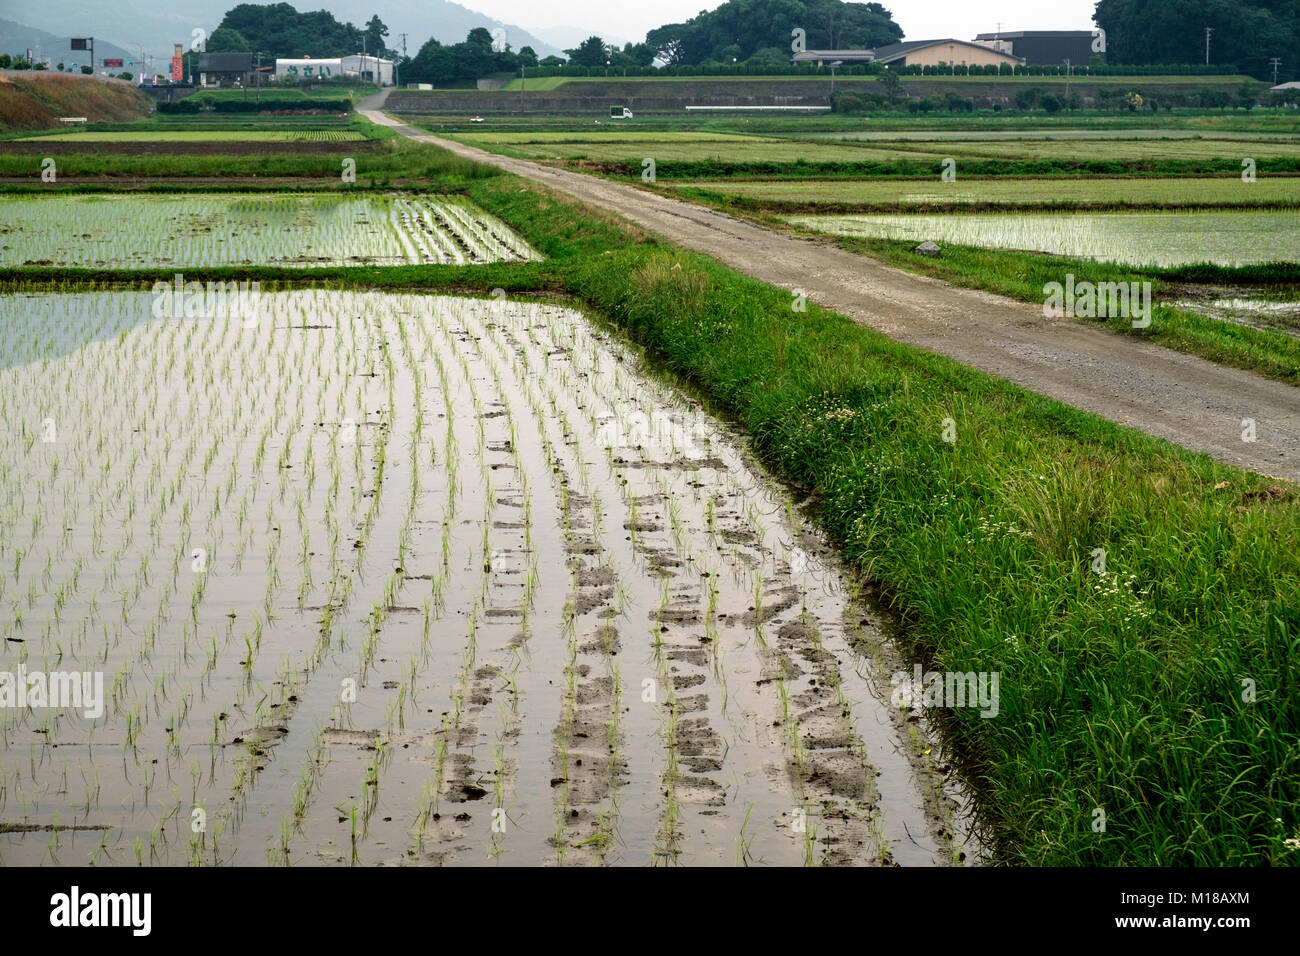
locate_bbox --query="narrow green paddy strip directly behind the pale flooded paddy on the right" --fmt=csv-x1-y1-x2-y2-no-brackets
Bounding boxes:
673,177,1300,207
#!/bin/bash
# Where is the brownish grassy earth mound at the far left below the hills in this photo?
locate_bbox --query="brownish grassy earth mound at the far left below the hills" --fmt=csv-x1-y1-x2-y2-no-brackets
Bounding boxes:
0,72,153,131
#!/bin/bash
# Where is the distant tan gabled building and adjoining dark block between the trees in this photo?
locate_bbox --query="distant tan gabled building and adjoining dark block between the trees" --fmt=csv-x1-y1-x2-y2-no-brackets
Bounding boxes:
793,30,1093,66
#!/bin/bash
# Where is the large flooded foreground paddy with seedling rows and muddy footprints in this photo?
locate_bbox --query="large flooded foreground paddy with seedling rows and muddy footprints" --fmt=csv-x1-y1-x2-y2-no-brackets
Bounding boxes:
0,291,975,865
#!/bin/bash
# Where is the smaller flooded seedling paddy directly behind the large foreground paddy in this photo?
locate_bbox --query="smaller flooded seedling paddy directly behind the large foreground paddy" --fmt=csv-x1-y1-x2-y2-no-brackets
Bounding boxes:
0,194,538,268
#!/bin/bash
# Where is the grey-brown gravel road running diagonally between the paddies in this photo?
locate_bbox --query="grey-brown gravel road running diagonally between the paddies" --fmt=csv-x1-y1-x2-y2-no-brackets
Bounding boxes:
361,100,1300,481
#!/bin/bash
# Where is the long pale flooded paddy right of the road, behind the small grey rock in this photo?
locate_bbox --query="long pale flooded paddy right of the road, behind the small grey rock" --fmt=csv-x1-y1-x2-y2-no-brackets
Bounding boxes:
789,210,1300,267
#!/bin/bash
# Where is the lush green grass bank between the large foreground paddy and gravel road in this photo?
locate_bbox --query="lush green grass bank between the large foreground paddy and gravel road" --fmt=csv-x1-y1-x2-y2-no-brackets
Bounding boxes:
5,141,1300,865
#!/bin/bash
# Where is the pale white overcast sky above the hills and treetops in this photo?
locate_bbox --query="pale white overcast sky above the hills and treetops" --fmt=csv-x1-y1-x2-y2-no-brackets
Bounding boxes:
473,0,1096,40
